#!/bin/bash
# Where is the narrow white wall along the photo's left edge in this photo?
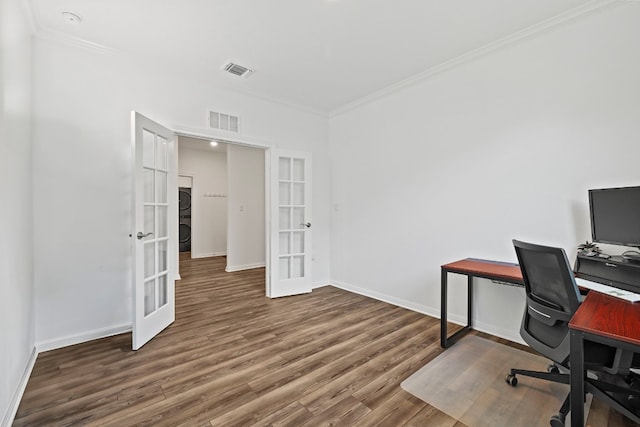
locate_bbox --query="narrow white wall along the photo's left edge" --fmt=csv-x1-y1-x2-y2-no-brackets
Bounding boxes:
0,0,35,426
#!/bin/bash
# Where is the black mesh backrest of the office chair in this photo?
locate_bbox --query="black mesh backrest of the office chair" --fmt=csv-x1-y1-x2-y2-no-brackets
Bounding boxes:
513,240,580,362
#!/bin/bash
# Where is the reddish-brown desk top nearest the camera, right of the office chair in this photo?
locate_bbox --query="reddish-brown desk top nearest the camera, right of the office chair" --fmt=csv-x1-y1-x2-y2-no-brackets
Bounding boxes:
569,291,640,345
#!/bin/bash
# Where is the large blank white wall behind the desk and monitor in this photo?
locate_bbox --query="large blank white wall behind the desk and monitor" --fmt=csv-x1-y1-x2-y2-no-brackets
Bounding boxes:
330,2,640,340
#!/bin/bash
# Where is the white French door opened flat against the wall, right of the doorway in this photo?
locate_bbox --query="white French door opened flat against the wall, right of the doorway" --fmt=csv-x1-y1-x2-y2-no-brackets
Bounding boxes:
267,149,312,298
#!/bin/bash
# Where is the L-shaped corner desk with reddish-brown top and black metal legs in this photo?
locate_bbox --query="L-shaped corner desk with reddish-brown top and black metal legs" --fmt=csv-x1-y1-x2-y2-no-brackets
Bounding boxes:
440,258,640,427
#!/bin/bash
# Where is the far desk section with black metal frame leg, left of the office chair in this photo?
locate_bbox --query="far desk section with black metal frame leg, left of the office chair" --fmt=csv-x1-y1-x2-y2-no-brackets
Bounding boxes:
440,258,524,348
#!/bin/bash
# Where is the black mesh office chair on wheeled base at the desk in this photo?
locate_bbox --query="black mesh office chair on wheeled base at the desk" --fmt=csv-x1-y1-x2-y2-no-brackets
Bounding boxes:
506,240,640,427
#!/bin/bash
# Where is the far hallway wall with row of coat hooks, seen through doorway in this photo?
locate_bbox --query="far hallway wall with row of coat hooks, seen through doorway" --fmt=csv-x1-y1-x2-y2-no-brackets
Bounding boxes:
178,143,227,258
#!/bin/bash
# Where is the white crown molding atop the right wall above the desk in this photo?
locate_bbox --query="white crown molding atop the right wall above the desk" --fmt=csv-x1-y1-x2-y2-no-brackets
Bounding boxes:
329,0,620,118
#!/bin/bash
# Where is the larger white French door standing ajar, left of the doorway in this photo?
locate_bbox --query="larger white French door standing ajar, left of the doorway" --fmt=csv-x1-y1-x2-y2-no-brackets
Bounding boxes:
131,111,177,350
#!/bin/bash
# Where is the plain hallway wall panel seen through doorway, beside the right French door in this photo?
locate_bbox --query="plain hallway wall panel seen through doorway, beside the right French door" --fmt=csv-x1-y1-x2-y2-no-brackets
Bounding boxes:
227,145,265,271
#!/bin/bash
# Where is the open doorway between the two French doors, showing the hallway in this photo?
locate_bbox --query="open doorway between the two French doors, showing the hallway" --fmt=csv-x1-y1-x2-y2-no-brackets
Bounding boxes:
177,135,267,278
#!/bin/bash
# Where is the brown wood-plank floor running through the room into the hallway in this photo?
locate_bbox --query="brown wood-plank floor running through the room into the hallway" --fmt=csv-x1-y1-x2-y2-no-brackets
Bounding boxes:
14,256,632,427
